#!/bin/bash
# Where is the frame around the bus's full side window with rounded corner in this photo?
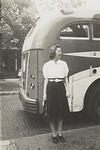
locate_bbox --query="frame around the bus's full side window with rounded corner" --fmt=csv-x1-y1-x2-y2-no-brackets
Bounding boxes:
58,21,91,40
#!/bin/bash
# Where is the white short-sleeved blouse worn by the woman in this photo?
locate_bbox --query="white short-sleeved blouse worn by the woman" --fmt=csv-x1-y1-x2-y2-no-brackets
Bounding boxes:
43,60,69,78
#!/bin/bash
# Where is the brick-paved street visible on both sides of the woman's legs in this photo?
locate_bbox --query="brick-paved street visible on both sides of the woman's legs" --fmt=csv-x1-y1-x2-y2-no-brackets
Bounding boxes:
1,94,98,140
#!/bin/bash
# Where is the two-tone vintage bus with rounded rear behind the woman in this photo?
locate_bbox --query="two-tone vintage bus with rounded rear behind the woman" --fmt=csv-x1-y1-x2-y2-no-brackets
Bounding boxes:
19,9,100,121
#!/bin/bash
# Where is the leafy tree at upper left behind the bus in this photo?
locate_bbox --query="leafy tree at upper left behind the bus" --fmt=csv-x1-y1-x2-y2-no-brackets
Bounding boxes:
0,0,38,48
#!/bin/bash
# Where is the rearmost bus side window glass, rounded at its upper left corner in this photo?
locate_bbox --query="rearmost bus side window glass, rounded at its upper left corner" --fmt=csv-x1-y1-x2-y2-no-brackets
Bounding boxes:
60,24,89,38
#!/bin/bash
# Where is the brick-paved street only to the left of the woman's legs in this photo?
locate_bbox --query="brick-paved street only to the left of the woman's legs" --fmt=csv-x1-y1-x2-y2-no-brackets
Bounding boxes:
1,95,50,140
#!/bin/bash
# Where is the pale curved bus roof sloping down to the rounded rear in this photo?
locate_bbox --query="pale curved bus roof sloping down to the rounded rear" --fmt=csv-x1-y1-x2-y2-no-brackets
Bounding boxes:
22,9,100,52
